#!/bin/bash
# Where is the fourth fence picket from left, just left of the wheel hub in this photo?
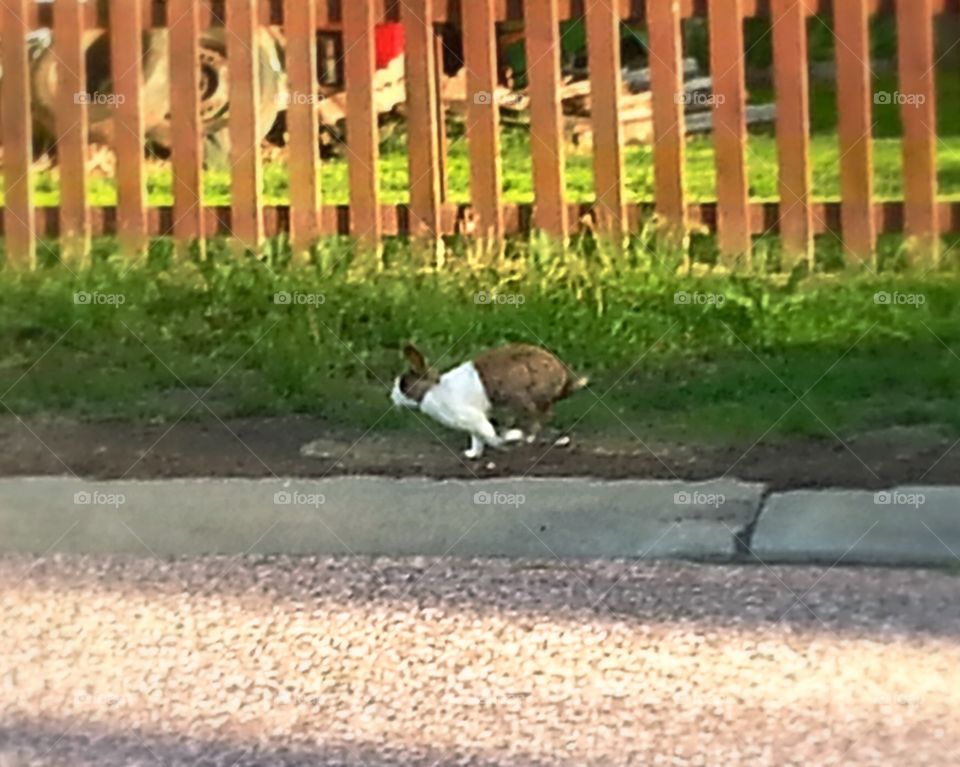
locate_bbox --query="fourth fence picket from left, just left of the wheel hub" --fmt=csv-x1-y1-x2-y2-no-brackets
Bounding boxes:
167,0,205,249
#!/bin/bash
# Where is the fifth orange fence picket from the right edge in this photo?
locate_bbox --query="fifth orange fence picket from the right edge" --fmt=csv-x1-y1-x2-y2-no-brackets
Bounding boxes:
648,0,687,243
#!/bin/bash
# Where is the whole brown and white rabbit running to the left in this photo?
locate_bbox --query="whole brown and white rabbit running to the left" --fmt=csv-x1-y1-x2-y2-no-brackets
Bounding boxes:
391,344,587,459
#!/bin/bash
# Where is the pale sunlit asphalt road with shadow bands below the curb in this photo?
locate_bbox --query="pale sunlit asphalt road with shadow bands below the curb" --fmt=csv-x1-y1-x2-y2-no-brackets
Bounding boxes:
0,556,960,767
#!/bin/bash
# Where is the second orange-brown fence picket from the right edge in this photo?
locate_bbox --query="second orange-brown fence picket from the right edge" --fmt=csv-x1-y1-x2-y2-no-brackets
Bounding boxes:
834,0,876,262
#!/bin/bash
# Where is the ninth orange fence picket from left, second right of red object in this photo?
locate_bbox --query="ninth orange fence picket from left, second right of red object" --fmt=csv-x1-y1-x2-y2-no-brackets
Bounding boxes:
461,0,504,238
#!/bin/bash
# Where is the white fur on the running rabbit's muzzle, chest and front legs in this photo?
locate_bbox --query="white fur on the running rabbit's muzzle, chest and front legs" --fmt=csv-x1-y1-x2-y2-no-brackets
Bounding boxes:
391,362,510,459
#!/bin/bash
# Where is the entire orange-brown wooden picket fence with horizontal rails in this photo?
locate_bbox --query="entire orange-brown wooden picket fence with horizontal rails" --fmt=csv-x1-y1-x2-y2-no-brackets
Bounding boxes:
0,0,948,267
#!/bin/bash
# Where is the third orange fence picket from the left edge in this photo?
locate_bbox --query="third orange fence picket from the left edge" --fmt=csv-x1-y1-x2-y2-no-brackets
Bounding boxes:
110,0,147,256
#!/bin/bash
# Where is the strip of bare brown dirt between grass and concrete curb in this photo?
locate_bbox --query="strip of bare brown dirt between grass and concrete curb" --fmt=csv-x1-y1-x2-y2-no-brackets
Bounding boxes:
0,417,960,489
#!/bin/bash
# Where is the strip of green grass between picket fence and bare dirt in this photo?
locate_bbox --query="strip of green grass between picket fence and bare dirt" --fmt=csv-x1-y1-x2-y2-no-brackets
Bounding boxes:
0,242,960,441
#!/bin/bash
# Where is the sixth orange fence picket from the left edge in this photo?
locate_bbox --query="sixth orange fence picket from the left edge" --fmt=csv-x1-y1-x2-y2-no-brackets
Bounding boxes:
284,0,320,253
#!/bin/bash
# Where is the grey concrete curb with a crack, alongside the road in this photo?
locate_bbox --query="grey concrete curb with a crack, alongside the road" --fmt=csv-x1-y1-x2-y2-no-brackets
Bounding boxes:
0,477,960,566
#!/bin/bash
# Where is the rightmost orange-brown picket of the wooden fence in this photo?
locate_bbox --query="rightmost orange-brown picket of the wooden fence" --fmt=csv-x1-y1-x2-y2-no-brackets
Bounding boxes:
897,0,940,259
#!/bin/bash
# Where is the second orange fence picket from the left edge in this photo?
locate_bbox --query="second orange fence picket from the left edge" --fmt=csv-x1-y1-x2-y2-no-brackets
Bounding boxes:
53,0,90,262
